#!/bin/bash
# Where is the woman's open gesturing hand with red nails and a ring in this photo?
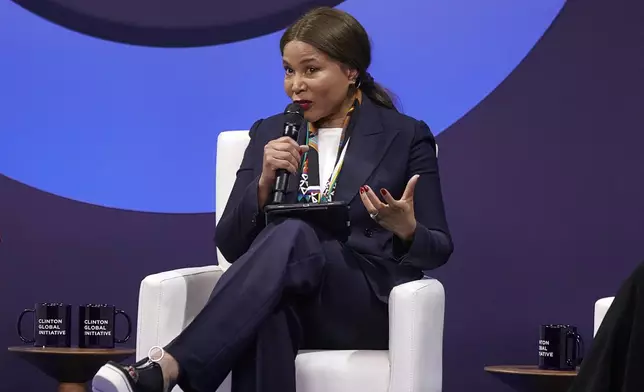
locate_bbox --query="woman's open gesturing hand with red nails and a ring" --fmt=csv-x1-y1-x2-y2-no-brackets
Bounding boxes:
360,174,419,241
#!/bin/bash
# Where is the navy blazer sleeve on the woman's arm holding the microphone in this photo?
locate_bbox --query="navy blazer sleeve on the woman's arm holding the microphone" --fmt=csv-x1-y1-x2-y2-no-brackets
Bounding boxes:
215,119,265,263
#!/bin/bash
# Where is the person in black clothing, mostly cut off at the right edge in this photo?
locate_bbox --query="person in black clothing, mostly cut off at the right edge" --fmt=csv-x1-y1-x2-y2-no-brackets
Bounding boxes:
569,262,644,392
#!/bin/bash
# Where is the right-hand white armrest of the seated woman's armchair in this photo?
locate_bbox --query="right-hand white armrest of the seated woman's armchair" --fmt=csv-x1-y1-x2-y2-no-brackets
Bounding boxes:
389,278,445,392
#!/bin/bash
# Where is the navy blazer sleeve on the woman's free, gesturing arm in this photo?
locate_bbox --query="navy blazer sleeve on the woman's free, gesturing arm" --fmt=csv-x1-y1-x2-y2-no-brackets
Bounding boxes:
393,121,454,270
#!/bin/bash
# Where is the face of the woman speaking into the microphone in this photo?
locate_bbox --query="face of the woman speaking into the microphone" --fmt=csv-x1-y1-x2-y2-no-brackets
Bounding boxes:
283,41,357,127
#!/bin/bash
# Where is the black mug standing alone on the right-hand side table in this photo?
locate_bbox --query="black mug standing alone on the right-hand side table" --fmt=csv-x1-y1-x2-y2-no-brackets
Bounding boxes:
539,324,584,370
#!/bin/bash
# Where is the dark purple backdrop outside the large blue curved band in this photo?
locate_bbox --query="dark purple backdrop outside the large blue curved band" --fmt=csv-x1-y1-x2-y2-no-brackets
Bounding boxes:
0,0,644,392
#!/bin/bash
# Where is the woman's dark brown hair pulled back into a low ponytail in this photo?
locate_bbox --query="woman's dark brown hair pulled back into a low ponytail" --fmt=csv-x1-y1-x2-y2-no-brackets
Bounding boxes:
280,7,396,109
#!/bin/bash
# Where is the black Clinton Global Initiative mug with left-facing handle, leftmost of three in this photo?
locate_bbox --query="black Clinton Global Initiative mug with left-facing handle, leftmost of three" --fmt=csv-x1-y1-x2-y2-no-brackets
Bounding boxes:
16,302,72,347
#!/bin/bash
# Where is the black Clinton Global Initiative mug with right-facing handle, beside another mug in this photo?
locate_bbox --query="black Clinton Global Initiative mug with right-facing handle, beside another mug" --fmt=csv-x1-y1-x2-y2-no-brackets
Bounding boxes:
78,304,132,348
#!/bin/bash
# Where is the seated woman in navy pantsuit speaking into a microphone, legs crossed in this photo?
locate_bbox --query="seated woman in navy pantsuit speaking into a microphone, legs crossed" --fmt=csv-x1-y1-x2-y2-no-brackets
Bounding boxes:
93,8,452,392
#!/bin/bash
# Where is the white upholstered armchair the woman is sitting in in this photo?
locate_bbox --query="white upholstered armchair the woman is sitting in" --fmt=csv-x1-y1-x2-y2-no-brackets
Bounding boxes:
136,131,445,392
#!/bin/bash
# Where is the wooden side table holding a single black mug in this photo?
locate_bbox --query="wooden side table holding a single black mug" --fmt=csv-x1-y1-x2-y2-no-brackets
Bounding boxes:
484,365,578,392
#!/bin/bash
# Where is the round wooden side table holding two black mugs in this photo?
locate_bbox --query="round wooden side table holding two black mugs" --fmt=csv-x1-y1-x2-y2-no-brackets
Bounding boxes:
9,346,135,392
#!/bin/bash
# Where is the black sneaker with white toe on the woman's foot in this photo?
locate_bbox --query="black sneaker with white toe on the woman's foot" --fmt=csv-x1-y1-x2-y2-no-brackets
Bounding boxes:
92,358,163,392
